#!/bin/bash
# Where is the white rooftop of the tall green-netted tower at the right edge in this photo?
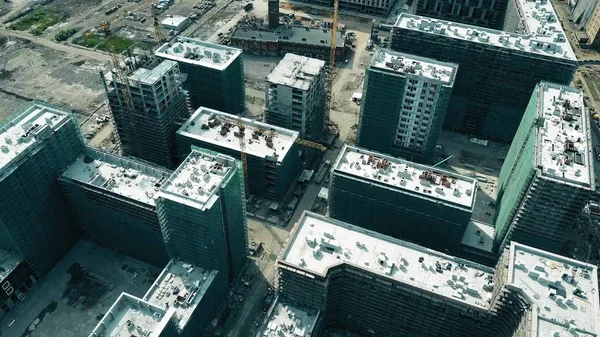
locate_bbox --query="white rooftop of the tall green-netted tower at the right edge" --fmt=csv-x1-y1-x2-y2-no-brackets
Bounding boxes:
535,82,595,189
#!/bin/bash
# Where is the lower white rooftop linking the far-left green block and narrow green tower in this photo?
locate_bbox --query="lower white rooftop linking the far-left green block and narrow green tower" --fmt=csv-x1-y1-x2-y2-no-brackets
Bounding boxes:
62,147,170,206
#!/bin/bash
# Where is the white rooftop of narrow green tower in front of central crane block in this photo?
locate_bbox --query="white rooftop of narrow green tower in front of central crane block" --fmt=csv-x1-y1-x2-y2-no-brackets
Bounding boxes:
159,149,236,209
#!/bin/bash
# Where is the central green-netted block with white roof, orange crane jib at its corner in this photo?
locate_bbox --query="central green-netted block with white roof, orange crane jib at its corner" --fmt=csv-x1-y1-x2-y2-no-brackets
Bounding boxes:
177,108,302,200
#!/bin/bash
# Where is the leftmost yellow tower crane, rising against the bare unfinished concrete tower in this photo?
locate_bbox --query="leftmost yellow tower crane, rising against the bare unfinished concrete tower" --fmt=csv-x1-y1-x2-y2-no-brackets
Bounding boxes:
100,21,137,156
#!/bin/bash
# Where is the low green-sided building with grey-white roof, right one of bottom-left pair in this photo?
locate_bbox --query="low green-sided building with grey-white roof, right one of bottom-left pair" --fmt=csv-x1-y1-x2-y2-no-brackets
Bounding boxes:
144,259,228,337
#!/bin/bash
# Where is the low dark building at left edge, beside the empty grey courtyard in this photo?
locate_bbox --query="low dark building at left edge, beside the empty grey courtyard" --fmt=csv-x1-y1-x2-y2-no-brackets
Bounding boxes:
0,248,36,320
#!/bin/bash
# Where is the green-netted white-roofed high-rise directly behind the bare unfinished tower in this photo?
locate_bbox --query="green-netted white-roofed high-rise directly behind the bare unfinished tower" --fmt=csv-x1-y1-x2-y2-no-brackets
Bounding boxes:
155,36,246,115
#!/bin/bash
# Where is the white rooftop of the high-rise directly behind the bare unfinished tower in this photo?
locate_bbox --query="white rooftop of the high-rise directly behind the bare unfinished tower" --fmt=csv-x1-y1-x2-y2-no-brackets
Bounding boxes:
154,36,242,70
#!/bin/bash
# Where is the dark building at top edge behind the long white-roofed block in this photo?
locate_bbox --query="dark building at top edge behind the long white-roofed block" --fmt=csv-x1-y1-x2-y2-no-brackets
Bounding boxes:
412,0,509,29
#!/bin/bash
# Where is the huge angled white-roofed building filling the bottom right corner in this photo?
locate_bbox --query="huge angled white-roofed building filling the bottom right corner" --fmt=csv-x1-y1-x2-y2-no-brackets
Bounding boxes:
277,212,599,337
